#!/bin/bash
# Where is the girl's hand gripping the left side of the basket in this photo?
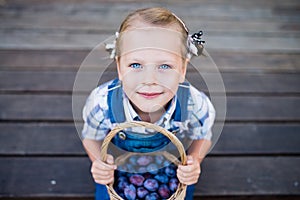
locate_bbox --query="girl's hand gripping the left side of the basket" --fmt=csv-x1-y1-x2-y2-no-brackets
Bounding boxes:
91,155,117,185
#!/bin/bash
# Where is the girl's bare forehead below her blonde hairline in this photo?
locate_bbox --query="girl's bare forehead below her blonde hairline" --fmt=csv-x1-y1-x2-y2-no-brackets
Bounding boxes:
119,27,183,56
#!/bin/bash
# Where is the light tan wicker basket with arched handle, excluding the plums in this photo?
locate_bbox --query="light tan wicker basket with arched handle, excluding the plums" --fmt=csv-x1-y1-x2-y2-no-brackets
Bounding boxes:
100,121,187,200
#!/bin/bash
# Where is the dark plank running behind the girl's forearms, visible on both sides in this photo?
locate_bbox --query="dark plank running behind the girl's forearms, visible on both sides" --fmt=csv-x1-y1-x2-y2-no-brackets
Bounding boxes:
0,123,300,156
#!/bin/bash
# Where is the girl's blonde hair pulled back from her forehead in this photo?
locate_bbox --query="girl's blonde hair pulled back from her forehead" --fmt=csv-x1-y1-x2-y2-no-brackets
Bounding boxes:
116,7,188,57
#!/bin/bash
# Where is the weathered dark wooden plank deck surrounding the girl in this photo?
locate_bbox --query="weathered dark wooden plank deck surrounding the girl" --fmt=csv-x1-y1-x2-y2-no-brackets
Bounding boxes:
0,0,300,200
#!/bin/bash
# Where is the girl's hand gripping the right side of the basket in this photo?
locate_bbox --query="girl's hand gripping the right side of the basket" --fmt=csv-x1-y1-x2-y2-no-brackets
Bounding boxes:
177,156,201,185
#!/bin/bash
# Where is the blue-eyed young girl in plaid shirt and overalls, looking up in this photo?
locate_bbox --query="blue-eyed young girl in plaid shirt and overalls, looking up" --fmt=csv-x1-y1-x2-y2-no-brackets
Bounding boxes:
82,8,215,200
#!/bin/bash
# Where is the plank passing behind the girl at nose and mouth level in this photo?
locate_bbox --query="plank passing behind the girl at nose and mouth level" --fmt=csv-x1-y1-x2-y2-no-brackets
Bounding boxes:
0,71,300,95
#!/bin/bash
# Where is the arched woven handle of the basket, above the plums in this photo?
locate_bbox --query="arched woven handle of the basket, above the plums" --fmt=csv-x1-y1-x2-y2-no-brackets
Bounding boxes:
100,121,187,165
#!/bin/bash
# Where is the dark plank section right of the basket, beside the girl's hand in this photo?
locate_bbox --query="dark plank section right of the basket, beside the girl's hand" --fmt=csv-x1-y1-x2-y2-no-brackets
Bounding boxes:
195,157,300,196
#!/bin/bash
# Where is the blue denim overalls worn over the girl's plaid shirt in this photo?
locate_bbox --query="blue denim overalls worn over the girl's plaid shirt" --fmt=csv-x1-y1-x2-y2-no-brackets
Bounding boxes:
95,79,194,200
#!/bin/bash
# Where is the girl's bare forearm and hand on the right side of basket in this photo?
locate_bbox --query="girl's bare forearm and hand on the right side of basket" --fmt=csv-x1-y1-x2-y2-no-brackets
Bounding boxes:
177,139,211,185
